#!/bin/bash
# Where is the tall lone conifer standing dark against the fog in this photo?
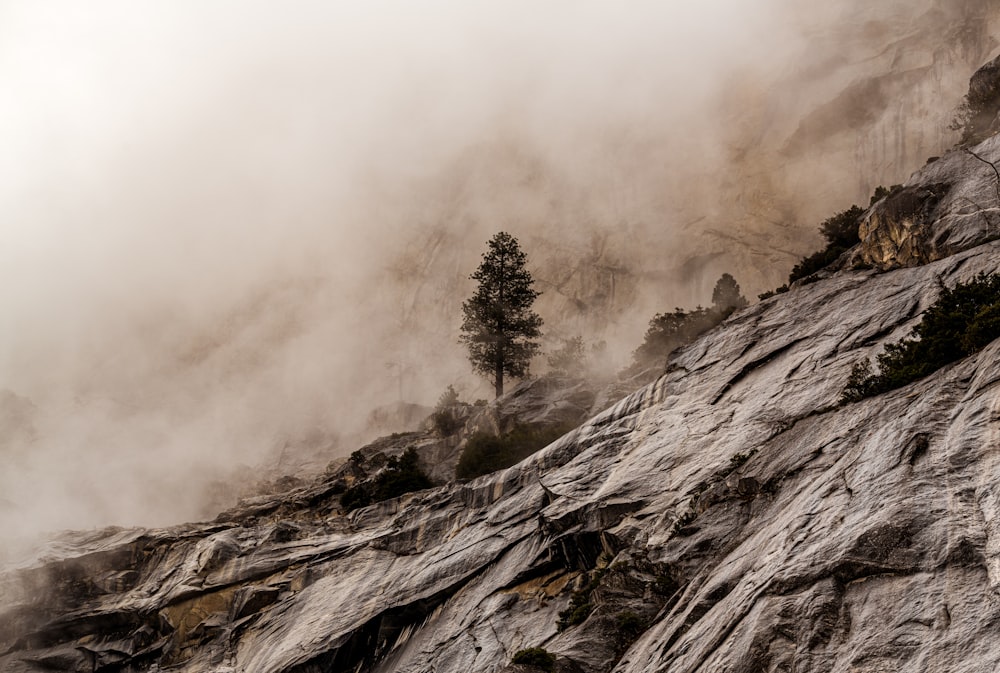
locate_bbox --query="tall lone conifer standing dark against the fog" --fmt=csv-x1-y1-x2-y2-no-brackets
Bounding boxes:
460,231,542,397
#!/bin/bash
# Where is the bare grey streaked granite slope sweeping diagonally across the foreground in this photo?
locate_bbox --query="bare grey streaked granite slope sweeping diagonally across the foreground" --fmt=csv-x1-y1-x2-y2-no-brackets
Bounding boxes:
0,232,1000,673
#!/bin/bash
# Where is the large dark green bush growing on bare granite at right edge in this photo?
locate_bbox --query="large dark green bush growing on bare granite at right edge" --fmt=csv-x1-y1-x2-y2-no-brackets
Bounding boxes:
841,273,1000,402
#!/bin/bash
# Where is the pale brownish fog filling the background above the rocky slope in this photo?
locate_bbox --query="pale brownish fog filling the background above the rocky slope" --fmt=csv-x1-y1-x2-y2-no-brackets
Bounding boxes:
0,0,995,536
